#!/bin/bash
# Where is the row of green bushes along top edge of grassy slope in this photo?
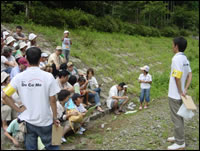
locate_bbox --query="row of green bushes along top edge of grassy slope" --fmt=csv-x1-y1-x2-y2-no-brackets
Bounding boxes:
1,4,195,37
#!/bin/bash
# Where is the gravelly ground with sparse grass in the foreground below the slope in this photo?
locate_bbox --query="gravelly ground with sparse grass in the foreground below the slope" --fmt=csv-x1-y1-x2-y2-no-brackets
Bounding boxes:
61,100,199,150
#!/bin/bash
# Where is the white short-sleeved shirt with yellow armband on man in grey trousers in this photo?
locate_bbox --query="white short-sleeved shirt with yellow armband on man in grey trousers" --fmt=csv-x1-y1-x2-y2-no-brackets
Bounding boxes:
168,52,192,100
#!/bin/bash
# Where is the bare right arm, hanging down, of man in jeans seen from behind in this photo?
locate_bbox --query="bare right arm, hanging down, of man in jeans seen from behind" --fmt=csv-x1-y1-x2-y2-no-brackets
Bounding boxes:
50,95,60,126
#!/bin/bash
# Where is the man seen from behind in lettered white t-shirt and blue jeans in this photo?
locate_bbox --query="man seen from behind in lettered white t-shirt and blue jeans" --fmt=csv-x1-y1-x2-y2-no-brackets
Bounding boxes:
3,47,60,150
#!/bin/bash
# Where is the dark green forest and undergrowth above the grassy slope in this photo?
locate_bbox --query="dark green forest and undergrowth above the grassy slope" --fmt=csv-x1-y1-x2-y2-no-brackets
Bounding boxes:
1,1,199,37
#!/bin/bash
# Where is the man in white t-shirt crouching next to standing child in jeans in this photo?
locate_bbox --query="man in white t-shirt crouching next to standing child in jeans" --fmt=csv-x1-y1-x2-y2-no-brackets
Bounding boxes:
106,82,128,115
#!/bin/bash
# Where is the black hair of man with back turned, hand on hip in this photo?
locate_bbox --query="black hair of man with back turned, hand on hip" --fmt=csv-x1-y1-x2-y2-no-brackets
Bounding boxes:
26,47,42,65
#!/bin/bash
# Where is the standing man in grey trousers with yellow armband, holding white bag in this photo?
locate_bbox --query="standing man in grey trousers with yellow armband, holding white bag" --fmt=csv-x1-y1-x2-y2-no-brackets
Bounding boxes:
168,37,192,150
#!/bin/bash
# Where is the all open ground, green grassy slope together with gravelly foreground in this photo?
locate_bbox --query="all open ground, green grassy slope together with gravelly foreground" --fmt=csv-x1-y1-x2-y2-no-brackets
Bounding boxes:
3,24,199,149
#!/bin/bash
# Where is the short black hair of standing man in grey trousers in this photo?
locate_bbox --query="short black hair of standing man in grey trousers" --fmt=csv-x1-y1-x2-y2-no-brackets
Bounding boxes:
173,37,187,52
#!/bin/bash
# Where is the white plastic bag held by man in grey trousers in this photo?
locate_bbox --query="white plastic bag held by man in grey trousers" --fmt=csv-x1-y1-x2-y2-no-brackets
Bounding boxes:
177,103,194,120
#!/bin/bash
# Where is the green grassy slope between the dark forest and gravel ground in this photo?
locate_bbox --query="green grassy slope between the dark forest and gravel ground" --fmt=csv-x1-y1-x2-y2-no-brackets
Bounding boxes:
5,24,199,104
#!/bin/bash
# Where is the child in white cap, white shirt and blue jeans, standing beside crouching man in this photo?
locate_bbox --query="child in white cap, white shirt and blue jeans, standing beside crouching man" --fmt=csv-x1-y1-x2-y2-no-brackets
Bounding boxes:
138,66,152,110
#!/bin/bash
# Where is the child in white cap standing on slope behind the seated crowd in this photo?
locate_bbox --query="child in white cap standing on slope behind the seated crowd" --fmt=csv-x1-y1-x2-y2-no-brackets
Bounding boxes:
62,31,72,62
